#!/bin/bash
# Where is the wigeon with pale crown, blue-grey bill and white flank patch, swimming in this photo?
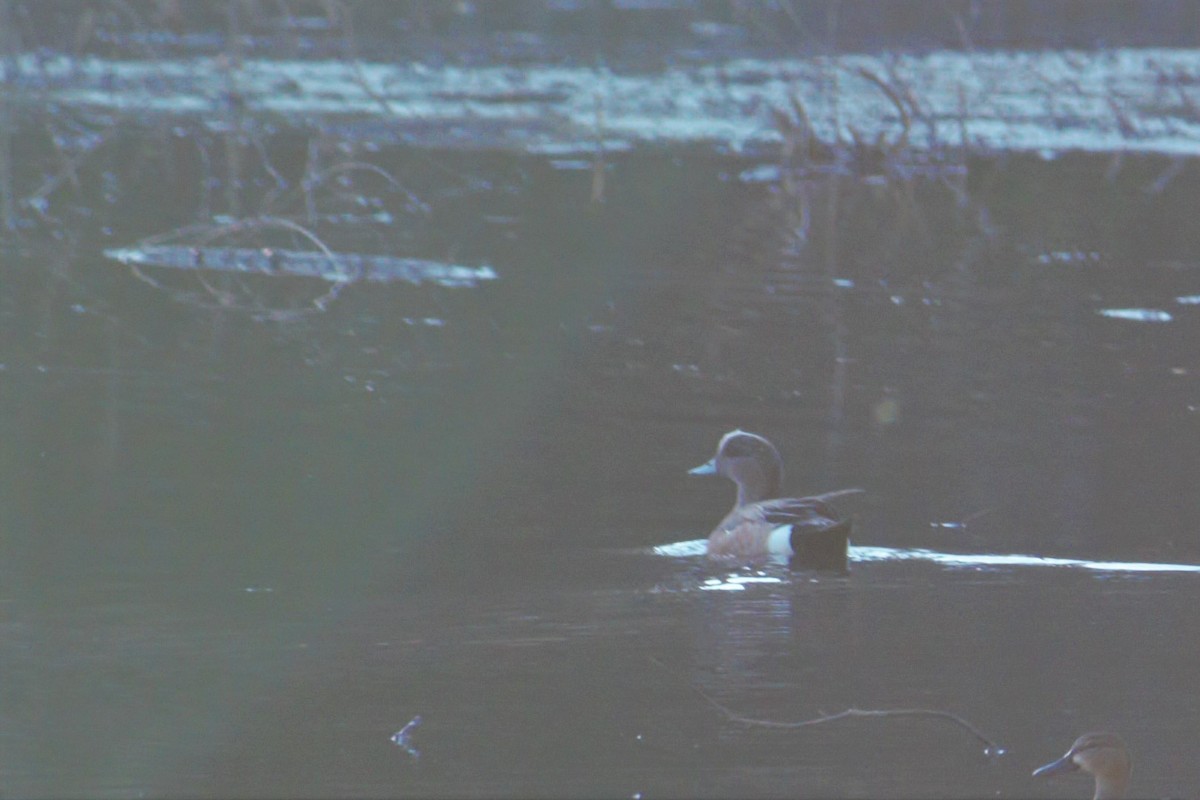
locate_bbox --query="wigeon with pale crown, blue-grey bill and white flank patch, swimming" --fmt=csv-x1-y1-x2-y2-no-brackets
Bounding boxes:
688,431,860,570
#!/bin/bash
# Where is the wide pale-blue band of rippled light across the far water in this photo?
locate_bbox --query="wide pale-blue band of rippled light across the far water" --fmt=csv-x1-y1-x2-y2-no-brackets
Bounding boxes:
25,48,1196,158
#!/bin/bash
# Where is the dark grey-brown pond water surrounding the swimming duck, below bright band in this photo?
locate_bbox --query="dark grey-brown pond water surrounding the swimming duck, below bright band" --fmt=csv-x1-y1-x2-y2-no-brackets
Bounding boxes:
0,148,1200,798
